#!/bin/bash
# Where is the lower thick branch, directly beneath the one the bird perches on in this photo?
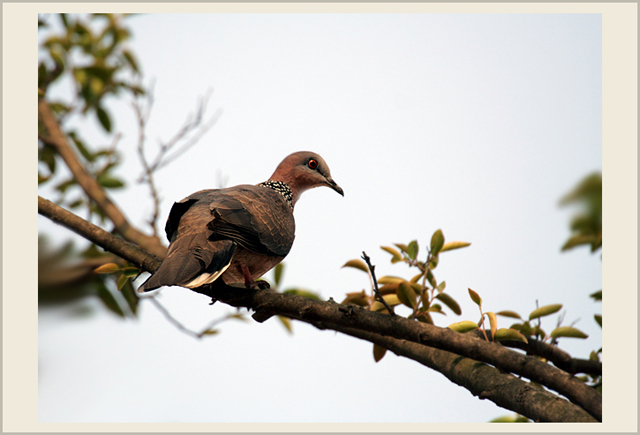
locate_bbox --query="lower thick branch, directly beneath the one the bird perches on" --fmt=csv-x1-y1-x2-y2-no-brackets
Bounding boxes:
332,324,597,422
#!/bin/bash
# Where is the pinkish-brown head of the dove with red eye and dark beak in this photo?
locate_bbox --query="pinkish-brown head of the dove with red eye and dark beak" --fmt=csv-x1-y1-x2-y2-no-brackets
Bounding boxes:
269,151,344,205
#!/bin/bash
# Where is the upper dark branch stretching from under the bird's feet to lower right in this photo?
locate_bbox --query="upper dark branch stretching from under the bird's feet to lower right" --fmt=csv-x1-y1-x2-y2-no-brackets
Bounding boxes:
194,281,602,420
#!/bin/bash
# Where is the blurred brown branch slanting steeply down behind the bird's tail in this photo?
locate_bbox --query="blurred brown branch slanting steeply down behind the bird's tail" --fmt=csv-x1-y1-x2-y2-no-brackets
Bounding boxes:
38,99,167,258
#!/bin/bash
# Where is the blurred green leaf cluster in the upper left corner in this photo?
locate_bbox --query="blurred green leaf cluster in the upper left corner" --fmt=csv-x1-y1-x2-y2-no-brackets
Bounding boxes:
38,14,145,218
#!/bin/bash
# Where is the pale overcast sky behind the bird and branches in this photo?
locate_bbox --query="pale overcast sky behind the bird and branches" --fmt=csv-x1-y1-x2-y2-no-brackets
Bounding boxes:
38,14,602,423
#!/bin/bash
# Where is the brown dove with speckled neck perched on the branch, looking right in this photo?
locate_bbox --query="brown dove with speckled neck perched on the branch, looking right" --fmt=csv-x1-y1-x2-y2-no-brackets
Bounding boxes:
138,151,344,293
